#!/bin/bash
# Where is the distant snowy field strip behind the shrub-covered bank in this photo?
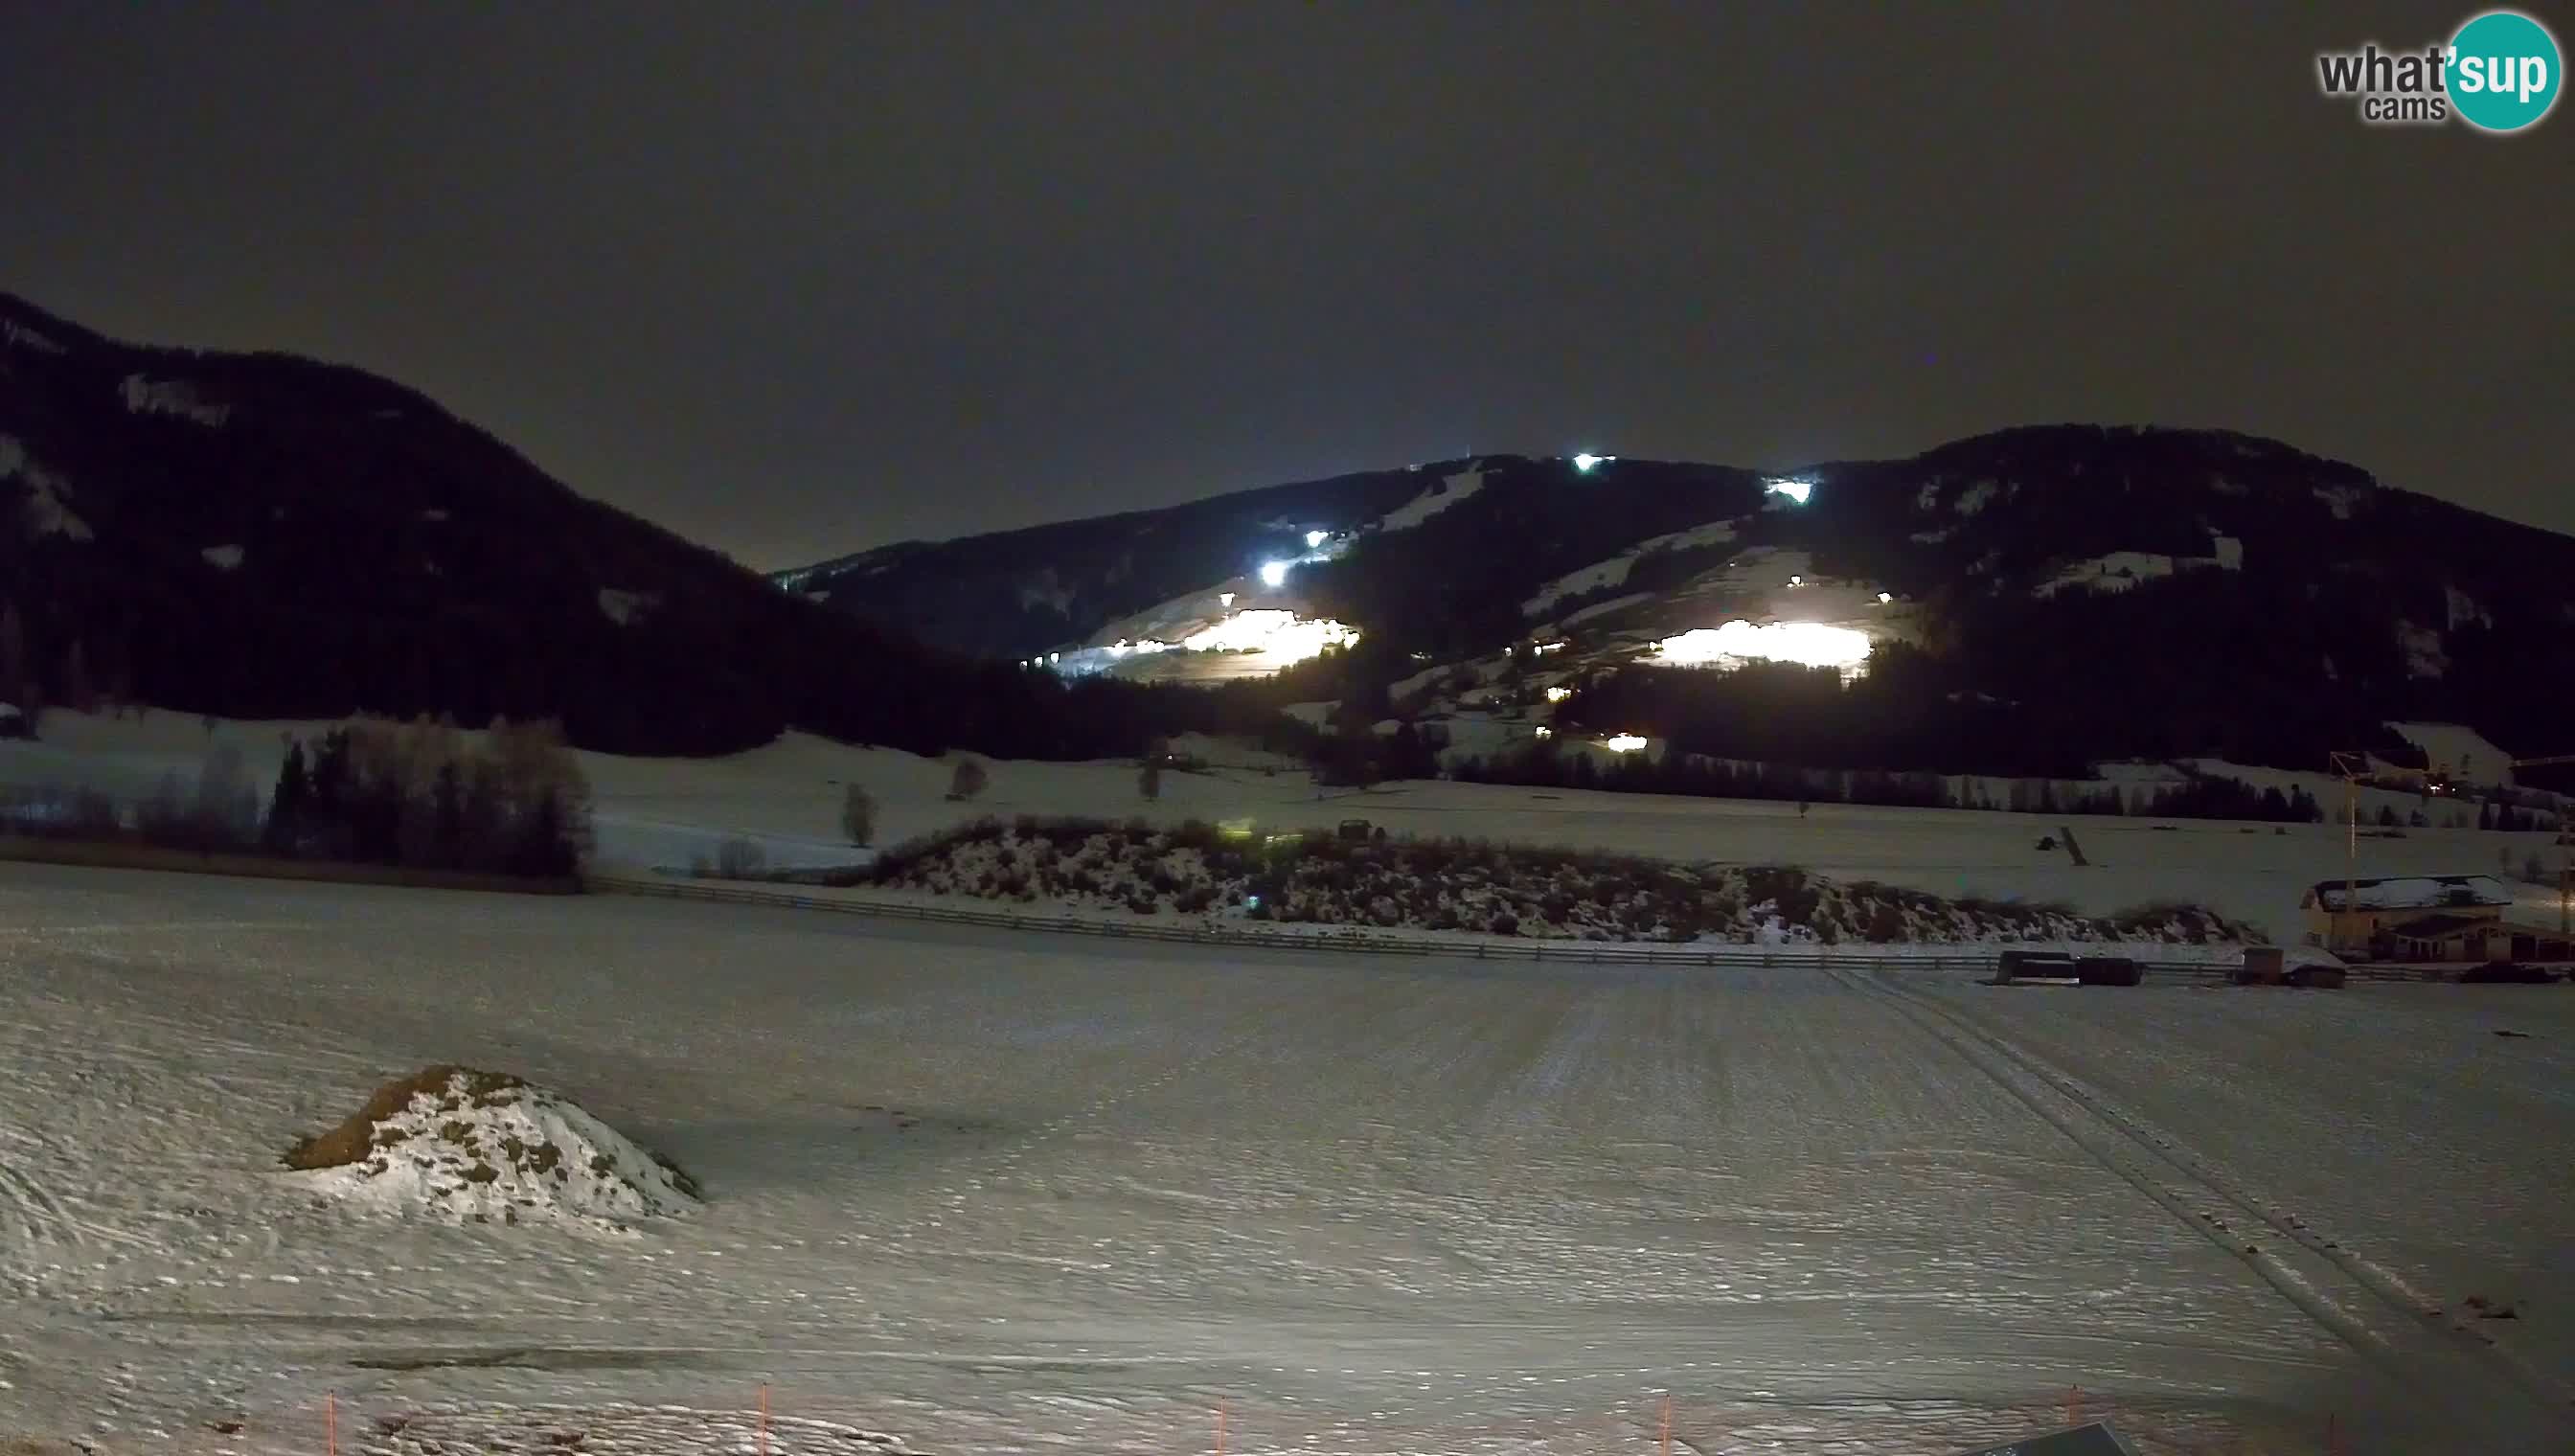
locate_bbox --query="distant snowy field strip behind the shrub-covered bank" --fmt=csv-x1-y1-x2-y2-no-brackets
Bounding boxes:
0,712,2563,944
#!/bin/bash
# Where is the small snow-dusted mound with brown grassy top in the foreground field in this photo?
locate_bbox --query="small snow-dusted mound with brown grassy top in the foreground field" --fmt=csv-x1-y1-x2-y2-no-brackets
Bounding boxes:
285,1067,697,1229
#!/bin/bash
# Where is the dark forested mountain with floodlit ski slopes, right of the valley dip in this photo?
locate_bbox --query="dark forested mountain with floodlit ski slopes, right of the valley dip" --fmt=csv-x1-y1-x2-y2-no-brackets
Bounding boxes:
780,425,2575,765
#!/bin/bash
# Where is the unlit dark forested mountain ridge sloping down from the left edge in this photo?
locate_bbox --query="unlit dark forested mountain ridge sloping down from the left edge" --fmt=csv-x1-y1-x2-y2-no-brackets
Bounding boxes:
0,294,1138,753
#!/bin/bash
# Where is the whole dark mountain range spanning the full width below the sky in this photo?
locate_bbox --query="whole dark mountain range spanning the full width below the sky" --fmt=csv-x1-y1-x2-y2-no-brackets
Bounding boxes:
0,294,2575,773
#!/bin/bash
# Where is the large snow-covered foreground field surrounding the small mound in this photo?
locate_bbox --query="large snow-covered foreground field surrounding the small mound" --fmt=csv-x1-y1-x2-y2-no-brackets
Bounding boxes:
0,866,2575,1456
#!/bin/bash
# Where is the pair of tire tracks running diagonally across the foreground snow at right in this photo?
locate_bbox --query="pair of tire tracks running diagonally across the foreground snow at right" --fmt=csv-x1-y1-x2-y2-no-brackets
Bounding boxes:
1826,969,2575,1438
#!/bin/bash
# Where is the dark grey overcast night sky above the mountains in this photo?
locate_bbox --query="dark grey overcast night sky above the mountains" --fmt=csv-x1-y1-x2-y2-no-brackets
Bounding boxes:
0,0,2575,567
